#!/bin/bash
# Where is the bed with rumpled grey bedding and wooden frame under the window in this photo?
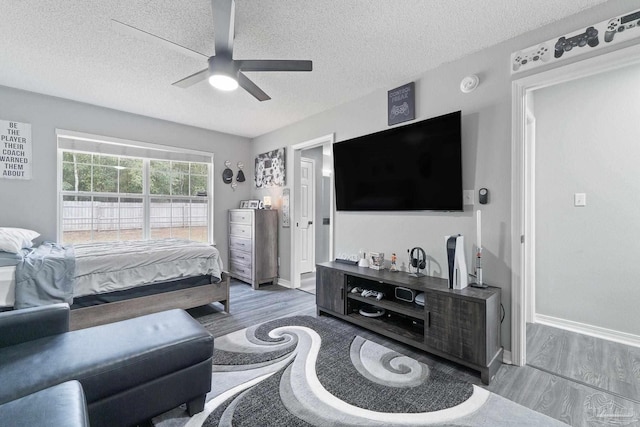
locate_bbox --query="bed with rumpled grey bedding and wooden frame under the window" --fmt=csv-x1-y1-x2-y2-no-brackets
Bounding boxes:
0,234,229,329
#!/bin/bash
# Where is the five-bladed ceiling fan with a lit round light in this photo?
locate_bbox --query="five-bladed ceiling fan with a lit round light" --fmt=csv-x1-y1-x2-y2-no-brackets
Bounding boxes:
111,0,313,101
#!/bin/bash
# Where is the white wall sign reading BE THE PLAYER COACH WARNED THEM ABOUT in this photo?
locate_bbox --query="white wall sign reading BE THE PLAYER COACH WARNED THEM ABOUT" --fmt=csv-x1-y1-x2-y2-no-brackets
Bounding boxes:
0,120,31,179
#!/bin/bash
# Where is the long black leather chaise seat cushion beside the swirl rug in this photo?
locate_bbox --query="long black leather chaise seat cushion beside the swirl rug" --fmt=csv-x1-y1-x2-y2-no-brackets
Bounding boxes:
0,310,213,403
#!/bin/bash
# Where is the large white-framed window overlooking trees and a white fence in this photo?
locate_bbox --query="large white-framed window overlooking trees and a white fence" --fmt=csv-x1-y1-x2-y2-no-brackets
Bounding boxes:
58,131,213,243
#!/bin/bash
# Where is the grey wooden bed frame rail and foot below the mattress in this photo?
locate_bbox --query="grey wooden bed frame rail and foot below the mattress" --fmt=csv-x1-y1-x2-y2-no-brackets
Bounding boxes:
69,271,229,330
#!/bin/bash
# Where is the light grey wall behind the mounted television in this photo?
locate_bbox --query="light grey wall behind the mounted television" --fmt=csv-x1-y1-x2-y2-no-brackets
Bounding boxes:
252,0,637,350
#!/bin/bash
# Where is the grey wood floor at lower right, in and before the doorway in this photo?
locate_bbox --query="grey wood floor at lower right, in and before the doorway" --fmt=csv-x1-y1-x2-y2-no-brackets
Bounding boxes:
508,324,640,426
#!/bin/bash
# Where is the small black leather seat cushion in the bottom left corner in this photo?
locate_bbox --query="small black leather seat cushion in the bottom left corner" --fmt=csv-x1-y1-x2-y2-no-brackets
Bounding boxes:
0,381,89,427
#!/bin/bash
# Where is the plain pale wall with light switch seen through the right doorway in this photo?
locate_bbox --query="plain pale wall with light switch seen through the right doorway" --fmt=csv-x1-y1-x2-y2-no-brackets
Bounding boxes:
534,65,640,335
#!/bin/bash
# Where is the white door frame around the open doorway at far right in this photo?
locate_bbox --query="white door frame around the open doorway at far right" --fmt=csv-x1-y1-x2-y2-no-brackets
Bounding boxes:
511,41,640,366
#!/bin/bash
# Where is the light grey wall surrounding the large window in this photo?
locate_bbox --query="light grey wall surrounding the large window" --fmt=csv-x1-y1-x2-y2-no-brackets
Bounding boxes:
0,86,253,263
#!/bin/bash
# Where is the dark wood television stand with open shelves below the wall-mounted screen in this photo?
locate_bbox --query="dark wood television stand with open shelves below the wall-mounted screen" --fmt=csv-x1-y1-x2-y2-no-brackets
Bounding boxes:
316,262,503,384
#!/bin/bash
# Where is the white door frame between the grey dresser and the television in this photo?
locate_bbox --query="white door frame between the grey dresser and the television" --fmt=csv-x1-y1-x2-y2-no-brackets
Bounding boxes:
290,133,335,288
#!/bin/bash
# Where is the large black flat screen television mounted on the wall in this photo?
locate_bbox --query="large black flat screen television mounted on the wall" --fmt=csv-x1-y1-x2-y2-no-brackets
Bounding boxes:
333,111,463,211
